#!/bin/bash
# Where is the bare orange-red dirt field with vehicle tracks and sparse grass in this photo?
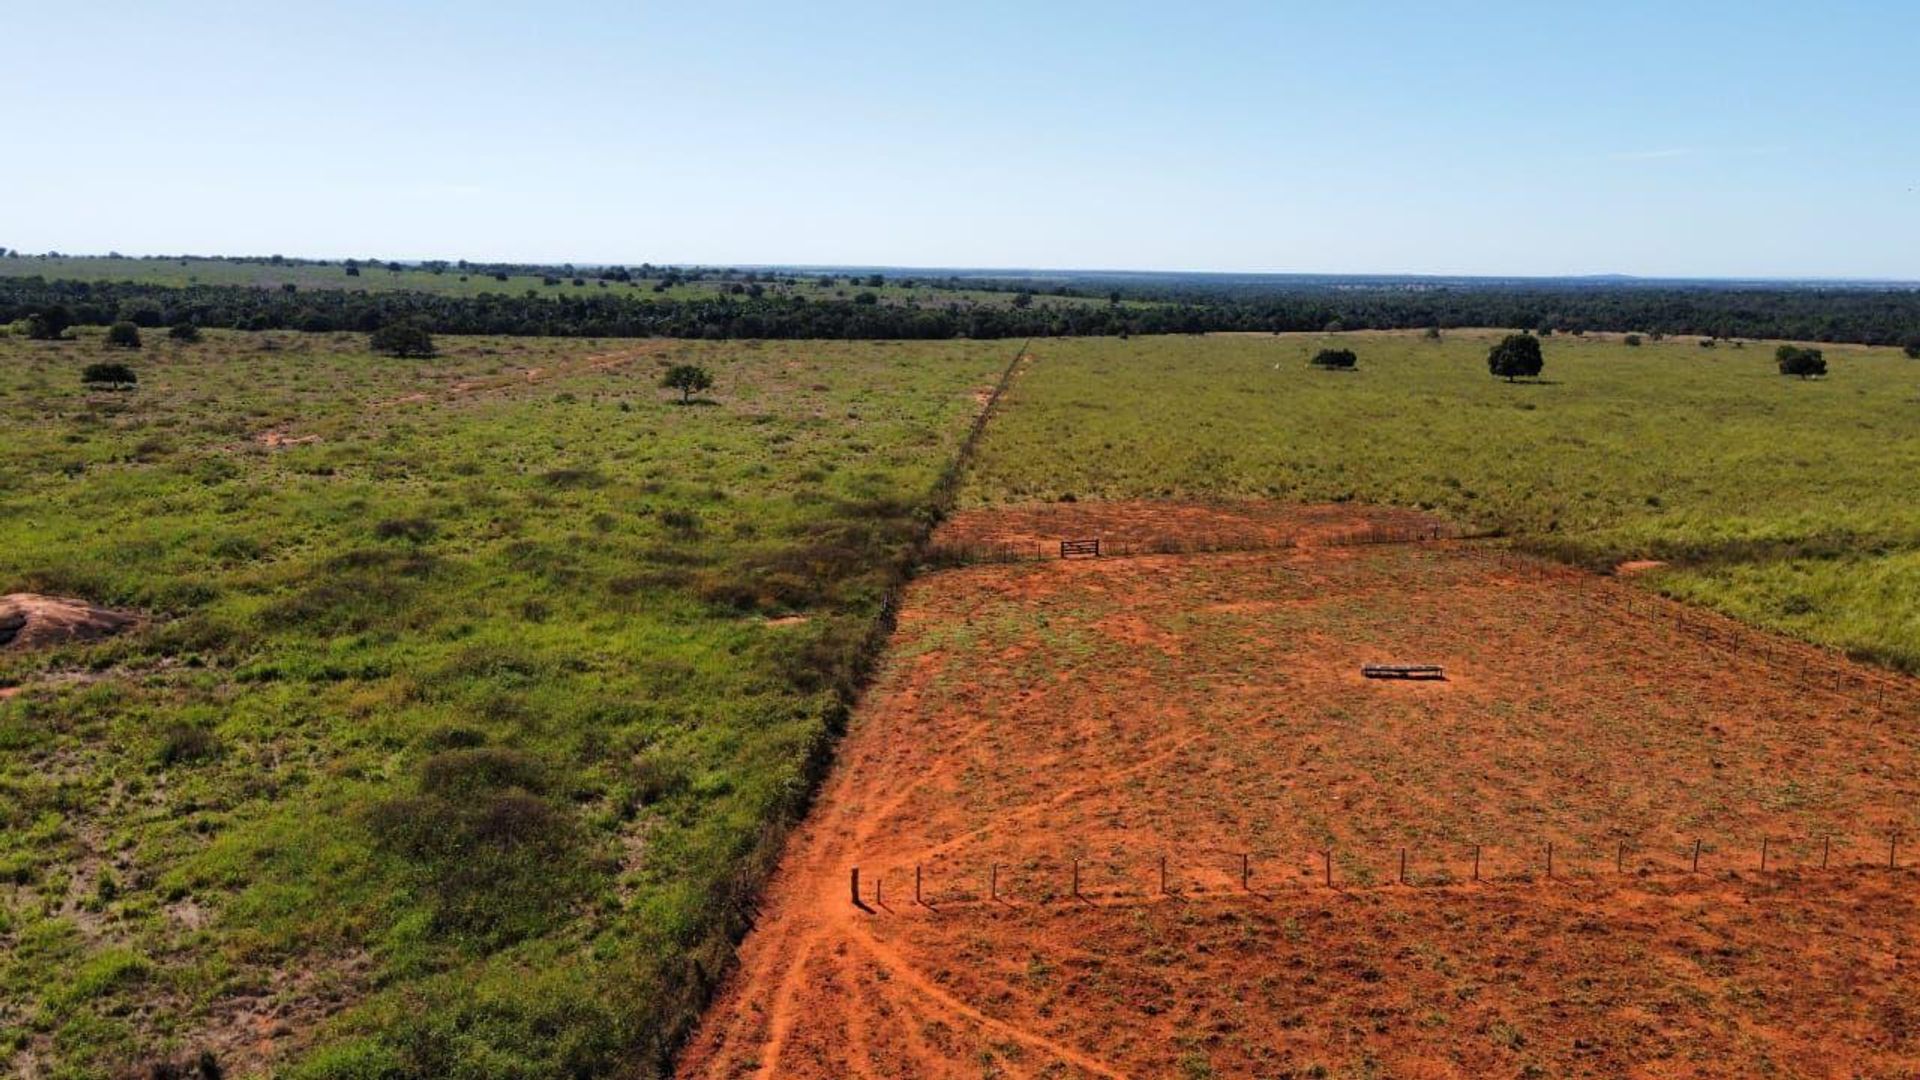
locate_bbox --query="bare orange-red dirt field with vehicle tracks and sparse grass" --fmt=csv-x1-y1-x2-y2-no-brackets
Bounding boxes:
680,507,1920,1080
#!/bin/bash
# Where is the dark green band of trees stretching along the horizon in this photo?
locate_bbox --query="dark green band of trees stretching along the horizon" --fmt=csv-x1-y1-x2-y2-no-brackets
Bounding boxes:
0,277,1920,344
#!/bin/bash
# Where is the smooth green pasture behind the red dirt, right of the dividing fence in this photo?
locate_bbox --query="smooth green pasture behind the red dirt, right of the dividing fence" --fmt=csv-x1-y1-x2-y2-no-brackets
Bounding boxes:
966,331,1920,671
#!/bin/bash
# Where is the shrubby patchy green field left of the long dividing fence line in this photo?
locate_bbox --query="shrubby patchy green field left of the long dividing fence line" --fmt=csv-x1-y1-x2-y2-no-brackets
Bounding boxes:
0,332,1014,1078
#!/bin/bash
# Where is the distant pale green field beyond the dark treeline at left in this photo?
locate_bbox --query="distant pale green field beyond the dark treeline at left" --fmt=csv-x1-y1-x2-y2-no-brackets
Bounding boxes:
0,256,1106,307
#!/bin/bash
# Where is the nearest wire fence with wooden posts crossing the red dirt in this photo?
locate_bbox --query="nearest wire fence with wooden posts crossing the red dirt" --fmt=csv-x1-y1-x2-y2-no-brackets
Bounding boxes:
847,832,1914,915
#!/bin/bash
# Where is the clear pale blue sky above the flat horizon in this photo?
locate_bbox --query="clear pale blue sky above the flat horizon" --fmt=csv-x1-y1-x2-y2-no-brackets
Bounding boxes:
0,0,1920,279
